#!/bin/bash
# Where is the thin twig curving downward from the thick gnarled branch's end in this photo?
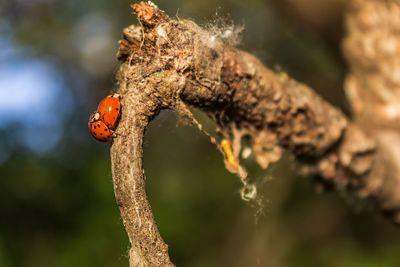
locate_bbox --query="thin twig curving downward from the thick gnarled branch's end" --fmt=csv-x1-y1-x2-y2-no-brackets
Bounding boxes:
111,69,174,267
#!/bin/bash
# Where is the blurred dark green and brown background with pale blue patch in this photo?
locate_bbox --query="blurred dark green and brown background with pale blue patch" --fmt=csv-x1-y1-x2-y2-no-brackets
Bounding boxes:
0,0,400,267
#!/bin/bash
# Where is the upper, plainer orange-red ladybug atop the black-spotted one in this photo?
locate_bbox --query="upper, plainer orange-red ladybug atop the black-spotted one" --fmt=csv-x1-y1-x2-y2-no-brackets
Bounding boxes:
97,94,121,130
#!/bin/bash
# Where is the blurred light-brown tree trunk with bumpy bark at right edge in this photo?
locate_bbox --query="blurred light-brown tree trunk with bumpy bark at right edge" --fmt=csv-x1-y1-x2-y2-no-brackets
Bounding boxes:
344,0,400,223
